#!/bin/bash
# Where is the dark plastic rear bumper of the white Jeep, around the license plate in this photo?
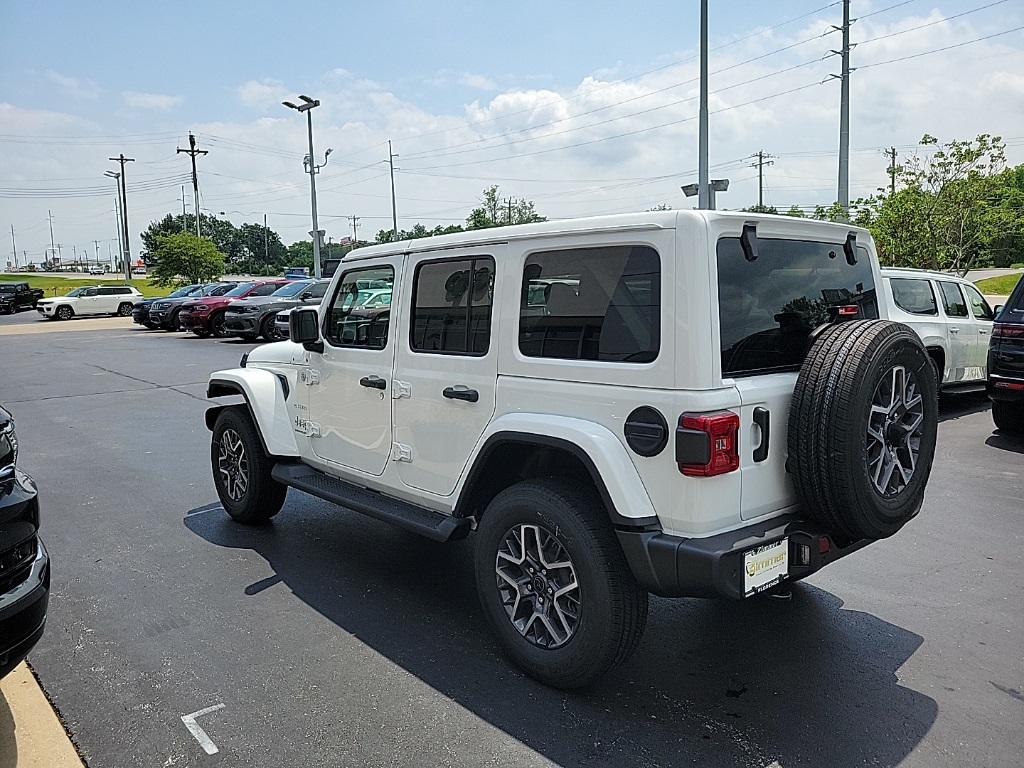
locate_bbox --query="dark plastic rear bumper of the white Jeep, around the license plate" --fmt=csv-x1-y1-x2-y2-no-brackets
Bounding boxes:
615,515,872,600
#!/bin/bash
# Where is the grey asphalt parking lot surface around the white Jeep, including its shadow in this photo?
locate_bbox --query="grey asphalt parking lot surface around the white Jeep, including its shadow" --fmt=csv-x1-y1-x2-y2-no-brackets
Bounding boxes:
0,312,1024,768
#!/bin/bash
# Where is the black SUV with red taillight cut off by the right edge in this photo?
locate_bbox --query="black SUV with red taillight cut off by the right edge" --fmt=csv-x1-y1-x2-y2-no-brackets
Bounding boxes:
985,280,1024,434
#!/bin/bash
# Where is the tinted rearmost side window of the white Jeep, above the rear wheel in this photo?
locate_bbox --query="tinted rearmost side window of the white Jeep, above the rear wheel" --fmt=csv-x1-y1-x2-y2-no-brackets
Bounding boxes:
519,246,662,362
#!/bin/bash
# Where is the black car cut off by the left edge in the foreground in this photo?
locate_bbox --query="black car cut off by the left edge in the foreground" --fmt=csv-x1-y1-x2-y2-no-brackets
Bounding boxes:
0,408,50,677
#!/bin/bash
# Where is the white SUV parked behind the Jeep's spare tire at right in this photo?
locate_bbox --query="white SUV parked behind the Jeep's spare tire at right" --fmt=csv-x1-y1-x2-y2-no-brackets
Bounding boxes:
882,266,994,390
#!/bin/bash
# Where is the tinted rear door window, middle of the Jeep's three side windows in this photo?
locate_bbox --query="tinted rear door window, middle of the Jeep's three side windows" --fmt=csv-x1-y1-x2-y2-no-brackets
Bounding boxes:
409,256,495,355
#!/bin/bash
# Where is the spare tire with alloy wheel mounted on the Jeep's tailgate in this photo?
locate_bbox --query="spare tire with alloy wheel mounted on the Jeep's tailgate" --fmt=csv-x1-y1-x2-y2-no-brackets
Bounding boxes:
786,321,938,540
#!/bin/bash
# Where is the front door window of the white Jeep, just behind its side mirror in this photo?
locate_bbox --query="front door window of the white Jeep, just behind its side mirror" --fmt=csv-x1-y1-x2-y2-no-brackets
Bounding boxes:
323,266,394,349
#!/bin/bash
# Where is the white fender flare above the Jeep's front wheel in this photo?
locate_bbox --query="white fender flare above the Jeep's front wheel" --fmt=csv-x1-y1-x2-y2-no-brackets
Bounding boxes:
206,368,299,457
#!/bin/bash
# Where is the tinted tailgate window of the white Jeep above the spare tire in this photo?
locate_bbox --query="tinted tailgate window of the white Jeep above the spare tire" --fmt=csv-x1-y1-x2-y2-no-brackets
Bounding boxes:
718,238,879,376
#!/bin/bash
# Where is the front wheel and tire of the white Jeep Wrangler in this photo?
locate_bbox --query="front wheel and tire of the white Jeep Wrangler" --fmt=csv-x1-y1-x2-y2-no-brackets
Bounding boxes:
210,406,288,523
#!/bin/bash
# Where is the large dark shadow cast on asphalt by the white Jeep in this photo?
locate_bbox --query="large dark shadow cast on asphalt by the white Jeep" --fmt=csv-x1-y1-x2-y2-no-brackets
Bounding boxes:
184,505,937,768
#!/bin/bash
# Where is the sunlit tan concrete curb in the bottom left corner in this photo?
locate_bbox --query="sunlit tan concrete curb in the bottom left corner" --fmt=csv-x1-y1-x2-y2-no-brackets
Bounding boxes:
0,662,85,768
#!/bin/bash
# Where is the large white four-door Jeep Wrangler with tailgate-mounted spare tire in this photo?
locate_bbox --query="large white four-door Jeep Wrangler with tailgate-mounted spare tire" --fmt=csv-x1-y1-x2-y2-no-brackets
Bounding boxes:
207,211,938,688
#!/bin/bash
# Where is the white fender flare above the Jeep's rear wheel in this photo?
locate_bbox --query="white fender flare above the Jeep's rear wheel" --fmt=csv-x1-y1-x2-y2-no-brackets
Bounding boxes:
456,413,660,526
